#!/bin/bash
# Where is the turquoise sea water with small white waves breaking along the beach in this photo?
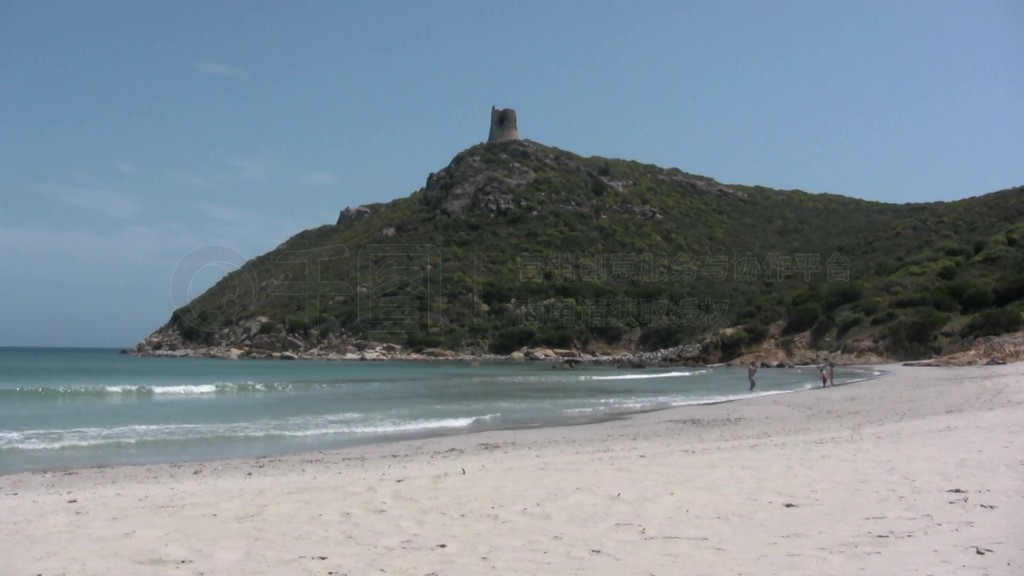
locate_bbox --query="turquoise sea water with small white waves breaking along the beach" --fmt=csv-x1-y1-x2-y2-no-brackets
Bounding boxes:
0,348,871,474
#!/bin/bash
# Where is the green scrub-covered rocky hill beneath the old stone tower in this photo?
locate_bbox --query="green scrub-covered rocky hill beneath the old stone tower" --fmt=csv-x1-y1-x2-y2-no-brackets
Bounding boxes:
139,140,1024,359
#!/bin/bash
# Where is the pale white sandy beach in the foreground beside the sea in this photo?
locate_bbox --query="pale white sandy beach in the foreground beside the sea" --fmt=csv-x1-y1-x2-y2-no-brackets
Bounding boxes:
0,364,1024,576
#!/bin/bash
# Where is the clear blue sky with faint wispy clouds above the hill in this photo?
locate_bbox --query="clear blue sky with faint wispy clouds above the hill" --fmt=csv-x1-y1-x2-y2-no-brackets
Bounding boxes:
0,0,1024,346
